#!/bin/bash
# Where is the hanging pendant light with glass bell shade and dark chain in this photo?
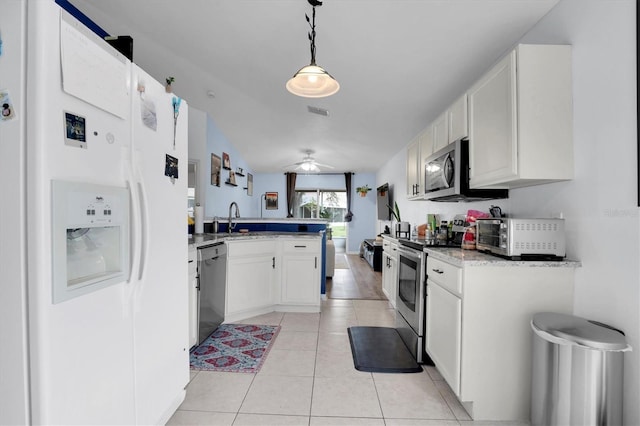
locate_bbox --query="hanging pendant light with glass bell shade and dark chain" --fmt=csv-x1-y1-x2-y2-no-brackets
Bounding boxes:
287,0,340,98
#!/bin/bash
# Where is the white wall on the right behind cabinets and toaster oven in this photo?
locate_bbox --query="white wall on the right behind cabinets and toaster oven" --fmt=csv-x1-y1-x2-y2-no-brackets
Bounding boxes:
377,0,640,425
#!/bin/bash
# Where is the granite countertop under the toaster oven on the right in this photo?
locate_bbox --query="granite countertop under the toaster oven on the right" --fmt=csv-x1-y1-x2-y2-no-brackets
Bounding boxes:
424,247,582,268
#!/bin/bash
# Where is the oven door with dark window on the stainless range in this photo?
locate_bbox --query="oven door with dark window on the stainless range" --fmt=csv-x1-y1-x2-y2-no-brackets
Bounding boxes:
396,247,424,336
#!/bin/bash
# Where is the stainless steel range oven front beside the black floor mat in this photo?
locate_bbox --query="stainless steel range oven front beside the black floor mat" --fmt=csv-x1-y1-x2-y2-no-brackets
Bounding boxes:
396,240,433,365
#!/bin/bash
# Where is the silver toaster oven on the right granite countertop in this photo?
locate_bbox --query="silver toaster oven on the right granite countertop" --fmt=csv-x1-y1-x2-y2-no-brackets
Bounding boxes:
476,218,566,260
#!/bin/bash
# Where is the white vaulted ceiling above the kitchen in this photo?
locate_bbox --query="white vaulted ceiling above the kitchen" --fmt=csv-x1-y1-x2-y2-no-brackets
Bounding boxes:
71,0,559,173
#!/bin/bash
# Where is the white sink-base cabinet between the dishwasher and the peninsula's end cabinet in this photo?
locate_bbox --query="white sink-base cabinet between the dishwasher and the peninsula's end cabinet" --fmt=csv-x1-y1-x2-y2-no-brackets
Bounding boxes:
225,240,276,320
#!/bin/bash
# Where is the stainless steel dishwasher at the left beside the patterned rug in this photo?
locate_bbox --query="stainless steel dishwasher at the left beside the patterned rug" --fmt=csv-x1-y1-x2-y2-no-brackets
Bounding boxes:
198,243,227,344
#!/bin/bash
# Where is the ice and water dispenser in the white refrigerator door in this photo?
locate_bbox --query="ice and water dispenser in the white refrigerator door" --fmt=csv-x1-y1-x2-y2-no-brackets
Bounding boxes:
52,181,129,303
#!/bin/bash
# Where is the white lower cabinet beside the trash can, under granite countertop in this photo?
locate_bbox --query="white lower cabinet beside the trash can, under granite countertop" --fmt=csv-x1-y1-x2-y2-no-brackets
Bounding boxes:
425,250,577,421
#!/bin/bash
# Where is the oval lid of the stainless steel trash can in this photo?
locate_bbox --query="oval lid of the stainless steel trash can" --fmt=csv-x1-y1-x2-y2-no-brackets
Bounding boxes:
531,312,629,351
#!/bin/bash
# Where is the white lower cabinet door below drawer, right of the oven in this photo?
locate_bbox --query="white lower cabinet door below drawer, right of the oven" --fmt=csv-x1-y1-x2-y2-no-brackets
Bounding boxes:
426,281,462,395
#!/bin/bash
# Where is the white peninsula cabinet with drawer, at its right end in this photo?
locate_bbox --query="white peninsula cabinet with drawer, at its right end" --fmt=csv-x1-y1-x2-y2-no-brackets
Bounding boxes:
280,239,322,306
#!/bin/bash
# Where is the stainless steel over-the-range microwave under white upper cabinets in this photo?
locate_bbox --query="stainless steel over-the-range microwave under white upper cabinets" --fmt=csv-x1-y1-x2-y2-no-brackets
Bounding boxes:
424,139,509,201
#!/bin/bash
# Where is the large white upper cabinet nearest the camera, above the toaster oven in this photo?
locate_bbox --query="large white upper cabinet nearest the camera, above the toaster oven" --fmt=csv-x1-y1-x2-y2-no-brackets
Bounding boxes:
468,45,573,188
